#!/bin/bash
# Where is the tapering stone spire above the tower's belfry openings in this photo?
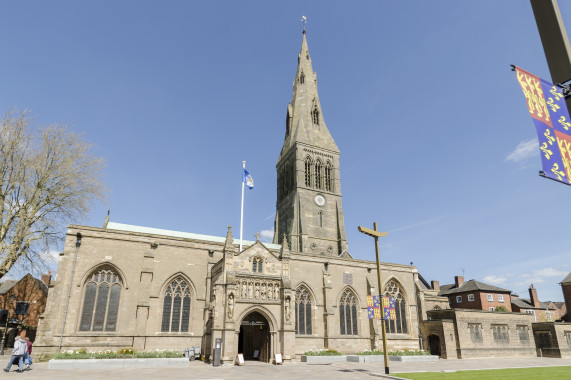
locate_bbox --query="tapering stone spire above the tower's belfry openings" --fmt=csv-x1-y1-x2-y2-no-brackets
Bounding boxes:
280,30,339,157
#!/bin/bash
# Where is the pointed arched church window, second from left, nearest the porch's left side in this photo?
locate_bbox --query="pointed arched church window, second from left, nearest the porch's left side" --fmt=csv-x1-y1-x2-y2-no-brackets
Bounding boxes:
161,276,190,332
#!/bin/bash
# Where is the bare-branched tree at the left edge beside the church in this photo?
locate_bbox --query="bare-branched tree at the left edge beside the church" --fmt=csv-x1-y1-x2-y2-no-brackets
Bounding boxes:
0,111,103,278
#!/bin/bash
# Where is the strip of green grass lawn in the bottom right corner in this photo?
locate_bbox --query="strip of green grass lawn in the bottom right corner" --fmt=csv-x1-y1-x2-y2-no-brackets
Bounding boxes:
391,367,571,380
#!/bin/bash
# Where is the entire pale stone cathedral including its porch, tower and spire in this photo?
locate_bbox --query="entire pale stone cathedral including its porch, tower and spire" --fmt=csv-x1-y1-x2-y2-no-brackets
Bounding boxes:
34,32,448,362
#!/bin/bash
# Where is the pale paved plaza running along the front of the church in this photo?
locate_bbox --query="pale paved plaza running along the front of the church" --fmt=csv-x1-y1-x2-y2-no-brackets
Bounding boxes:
0,357,571,380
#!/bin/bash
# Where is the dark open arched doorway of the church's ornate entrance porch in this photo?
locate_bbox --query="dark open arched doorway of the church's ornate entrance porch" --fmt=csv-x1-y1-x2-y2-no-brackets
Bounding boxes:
238,311,271,363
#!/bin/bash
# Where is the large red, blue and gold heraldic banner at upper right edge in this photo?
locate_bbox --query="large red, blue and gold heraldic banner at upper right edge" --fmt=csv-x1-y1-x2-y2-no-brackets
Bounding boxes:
515,67,571,185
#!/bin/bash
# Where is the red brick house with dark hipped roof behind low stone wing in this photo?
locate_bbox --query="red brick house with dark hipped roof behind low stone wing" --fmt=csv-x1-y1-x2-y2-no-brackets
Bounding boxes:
432,276,512,311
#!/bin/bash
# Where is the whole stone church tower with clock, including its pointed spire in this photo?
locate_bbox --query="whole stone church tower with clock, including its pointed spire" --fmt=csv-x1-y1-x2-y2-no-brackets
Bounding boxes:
274,30,347,256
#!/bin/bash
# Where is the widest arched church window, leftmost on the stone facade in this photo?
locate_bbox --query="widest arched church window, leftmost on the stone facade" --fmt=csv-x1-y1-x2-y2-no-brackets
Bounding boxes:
79,267,123,331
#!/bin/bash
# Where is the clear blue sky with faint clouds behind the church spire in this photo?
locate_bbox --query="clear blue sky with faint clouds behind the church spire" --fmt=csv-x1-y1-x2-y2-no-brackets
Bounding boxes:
0,0,571,300
